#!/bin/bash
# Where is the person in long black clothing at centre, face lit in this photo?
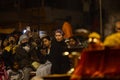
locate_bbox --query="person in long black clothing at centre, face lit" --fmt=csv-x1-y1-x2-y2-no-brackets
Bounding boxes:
49,29,70,74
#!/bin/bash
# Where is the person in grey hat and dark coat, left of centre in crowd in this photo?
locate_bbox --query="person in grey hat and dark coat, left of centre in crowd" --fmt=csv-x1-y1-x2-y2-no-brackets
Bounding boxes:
15,34,33,80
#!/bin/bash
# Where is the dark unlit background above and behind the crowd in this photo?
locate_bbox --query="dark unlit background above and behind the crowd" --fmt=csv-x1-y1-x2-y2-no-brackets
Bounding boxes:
0,0,120,36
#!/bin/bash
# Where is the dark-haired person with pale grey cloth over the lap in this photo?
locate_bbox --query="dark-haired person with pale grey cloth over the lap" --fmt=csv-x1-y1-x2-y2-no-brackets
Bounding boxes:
36,36,52,77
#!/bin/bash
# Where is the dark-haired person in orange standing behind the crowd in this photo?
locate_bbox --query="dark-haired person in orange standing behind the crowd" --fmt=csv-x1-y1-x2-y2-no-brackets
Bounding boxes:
62,16,73,39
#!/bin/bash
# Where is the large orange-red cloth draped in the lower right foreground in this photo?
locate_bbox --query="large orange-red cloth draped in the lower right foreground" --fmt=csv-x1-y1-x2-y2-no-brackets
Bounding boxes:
70,49,120,80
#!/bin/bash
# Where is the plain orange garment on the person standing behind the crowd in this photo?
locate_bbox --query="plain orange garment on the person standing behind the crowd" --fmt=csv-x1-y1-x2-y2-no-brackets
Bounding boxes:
62,21,73,39
